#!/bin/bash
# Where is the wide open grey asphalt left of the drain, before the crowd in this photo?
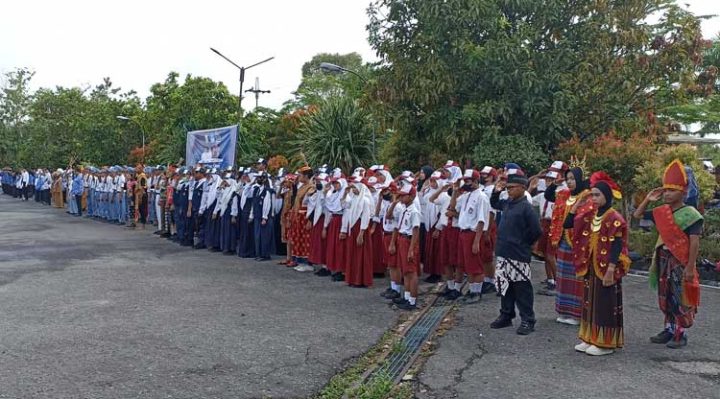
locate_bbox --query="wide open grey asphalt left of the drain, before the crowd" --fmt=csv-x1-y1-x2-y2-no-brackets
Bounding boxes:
0,195,396,399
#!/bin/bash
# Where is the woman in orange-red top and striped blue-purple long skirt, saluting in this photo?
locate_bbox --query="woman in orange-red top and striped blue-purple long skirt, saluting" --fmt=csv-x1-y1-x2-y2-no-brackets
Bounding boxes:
545,166,592,326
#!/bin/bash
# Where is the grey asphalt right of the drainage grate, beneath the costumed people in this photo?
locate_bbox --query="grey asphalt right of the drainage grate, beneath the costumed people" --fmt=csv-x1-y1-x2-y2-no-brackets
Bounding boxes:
418,265,720,399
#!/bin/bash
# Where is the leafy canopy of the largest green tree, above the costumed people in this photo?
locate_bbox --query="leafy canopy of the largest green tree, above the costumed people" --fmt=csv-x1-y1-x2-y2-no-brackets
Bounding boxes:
368,0,703,161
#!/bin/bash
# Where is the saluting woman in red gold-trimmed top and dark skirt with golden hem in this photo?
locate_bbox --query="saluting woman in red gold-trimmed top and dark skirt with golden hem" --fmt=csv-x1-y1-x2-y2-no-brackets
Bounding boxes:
564,172,630,356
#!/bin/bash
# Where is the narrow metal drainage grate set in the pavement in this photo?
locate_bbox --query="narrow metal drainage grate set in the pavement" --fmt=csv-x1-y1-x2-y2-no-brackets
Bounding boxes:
368,303,450,383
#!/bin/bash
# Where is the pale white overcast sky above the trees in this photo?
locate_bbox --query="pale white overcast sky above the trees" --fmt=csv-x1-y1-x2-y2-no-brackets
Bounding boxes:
0,0,720,110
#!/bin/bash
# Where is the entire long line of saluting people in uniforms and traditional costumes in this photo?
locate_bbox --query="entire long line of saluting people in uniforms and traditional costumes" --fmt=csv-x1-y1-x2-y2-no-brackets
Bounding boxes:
1,158,703,356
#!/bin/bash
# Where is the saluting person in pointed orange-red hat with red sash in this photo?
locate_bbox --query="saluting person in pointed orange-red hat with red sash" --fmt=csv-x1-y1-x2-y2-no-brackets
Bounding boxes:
633,159,703,349
